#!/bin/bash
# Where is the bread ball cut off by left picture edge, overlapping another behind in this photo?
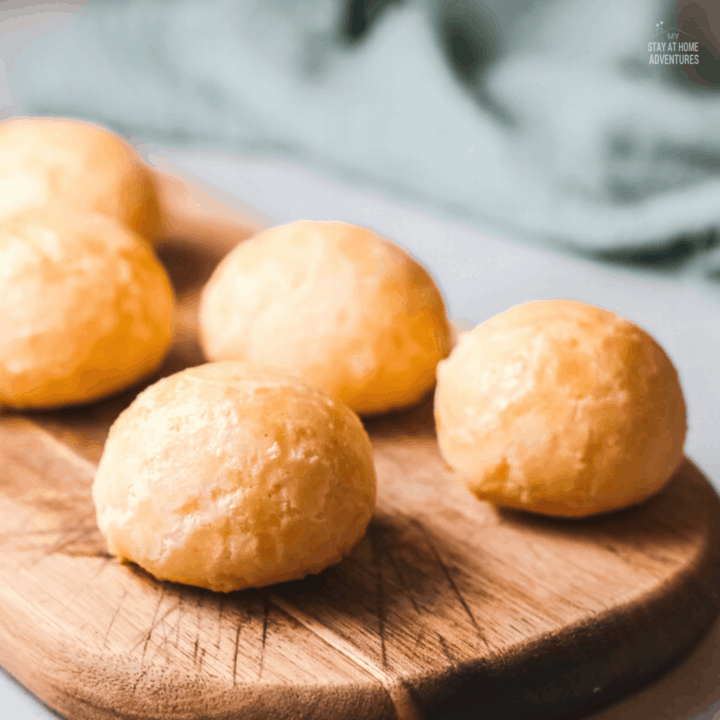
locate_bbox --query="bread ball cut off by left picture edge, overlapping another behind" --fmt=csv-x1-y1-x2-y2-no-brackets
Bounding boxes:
0,212,174,408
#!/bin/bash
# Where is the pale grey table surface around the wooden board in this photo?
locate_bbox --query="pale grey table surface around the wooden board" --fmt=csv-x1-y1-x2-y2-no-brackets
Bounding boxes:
0,148,720,720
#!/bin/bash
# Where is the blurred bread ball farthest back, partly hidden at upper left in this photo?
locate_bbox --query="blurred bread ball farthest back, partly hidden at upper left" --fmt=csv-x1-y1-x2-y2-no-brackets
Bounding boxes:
0,117,160,241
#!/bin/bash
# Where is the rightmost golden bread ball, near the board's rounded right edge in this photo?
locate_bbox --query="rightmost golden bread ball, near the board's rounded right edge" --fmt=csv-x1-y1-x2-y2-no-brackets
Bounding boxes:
435,300,687,516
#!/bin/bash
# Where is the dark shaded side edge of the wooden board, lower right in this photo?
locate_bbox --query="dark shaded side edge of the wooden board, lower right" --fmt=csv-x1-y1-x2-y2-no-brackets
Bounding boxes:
396,460,720,720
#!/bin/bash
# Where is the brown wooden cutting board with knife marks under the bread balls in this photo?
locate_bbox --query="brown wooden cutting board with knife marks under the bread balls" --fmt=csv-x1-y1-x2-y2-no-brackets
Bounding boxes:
0,170,720,720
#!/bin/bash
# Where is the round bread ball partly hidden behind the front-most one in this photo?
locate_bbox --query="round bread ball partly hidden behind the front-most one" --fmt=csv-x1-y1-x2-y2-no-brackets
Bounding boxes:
199,221,451,414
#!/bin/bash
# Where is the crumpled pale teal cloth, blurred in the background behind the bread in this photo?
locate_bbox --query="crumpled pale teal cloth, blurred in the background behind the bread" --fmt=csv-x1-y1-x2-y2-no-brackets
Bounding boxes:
8,0,720,277
